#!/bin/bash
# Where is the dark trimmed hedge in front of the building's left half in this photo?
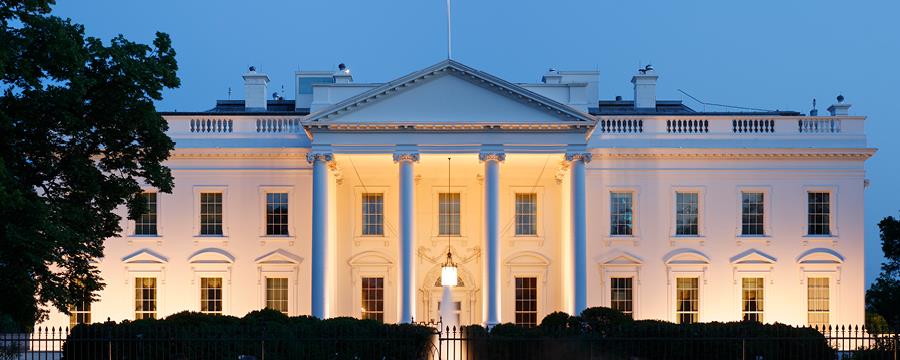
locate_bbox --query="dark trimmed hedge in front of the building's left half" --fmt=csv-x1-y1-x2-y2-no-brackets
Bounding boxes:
63,310,434,360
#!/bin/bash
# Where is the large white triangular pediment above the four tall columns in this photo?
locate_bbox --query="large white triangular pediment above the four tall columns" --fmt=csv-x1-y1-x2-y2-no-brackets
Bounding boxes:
306,60,593,126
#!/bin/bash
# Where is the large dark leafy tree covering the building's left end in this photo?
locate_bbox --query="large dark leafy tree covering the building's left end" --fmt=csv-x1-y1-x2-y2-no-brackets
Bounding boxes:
0,0,180,328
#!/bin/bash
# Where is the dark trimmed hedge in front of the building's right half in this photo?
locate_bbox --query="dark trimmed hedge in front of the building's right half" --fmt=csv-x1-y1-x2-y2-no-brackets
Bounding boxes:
463,307,834,359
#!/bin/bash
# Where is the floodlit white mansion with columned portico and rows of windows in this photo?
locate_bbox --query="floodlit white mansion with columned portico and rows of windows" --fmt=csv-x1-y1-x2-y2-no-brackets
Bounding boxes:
50,60,875,325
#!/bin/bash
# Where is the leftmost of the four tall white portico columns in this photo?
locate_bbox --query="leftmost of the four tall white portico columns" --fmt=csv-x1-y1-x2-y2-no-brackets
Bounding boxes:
306,152,334,319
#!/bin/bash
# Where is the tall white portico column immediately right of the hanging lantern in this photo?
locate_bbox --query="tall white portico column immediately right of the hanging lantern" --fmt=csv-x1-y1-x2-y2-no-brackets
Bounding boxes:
478,152,506,326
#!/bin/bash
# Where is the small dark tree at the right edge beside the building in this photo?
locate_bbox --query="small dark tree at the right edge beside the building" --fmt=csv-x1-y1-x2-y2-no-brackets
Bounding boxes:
866,216,900,329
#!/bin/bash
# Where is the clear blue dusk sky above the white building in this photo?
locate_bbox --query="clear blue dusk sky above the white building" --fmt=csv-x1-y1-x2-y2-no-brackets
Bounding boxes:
55,0,900,282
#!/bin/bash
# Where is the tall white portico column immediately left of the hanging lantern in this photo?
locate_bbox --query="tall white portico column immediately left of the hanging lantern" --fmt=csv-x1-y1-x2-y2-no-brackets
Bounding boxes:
394,152,419,323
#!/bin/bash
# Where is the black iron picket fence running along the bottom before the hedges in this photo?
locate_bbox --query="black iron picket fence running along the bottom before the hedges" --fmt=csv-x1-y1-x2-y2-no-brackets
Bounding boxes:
0,326,900,360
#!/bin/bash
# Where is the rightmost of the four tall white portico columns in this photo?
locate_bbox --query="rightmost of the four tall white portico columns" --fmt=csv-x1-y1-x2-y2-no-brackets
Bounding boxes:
566,152,591,315
